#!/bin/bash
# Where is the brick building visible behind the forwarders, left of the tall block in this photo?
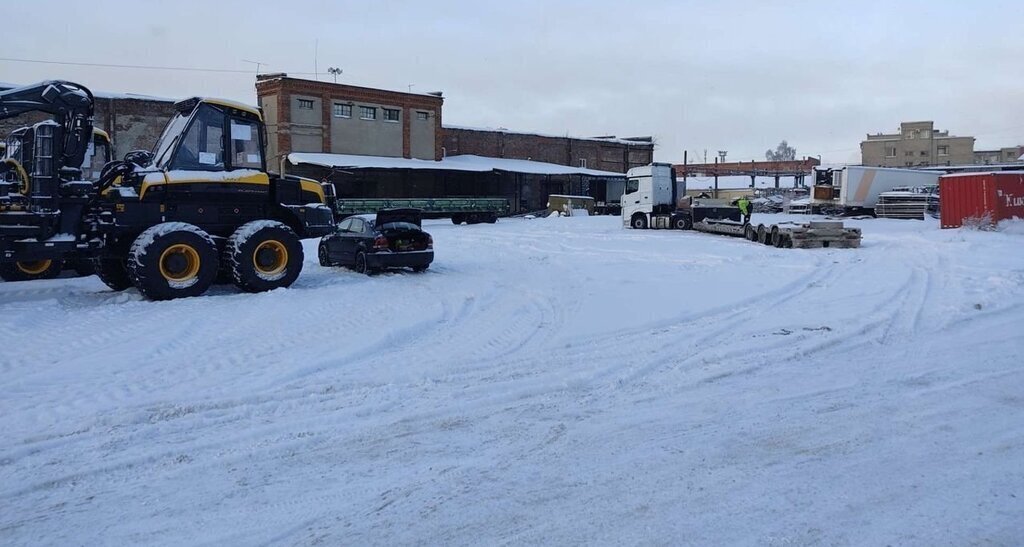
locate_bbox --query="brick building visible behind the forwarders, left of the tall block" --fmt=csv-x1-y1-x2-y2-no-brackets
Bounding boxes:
0,84,174,158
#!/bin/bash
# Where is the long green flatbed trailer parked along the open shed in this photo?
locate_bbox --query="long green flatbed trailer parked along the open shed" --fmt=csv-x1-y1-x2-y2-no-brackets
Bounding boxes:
334,198,511,224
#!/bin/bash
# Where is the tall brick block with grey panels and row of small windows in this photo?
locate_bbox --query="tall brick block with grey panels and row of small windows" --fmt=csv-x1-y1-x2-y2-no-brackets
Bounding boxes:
256,74,444,165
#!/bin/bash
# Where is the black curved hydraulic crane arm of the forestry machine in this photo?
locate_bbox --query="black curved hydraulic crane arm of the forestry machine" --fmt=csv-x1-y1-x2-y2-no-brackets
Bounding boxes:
0,80,95,178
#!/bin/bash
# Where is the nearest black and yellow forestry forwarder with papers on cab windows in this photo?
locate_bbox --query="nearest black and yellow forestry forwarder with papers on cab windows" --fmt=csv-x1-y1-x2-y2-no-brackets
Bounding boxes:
0,81,334,300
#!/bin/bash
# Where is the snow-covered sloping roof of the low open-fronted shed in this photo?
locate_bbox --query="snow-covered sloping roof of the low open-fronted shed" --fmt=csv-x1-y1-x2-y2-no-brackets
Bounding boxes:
288,152,626,178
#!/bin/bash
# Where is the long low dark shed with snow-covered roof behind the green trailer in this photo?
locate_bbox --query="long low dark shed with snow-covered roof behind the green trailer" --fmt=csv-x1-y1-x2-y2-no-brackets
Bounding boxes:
285,153,625,214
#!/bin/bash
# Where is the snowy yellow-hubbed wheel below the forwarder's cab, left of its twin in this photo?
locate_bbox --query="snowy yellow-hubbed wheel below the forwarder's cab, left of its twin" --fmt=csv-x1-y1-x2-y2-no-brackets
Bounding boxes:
128,222,218,300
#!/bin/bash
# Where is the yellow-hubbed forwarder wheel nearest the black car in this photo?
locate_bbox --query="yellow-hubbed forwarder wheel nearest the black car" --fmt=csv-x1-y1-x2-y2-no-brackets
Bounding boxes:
224,220,303,293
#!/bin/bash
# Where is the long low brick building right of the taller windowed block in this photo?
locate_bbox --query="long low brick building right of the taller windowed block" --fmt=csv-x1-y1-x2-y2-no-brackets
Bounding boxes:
444,126,654,173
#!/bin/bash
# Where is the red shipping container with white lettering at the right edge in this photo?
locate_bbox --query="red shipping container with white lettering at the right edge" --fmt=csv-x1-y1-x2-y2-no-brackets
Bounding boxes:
939,171,1024,227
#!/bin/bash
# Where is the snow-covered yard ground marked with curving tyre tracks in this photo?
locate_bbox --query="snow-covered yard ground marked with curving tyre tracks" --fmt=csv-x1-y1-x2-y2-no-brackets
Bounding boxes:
0,215,1024,545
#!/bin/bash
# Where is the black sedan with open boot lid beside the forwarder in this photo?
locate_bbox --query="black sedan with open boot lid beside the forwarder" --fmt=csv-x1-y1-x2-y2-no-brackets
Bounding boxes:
317,209,434,274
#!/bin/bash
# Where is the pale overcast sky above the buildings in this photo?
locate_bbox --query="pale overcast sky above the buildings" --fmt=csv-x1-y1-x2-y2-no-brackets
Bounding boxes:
0,0,1024,163
